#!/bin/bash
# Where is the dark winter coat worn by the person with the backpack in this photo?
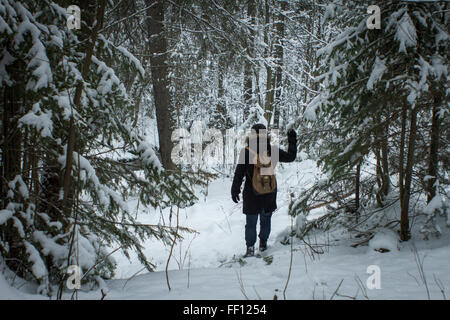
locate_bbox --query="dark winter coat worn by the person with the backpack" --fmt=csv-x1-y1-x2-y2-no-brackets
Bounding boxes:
231,134,297,214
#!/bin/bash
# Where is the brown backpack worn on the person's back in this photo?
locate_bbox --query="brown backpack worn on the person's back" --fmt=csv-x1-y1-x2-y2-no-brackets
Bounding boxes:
246,147,277,195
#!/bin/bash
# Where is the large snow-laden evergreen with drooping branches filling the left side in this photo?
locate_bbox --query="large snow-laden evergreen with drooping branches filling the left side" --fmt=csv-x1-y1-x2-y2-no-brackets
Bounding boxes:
0,0,195,297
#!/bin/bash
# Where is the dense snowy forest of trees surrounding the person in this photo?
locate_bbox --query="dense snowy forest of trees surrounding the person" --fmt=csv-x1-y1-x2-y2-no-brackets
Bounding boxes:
0,0,450,298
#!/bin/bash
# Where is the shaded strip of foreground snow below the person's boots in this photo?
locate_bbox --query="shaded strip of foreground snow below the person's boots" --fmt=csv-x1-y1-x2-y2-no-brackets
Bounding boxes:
67,230,450,299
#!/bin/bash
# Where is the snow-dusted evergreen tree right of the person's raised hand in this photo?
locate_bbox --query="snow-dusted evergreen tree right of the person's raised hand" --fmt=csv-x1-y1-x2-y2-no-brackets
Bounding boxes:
296,1,448,240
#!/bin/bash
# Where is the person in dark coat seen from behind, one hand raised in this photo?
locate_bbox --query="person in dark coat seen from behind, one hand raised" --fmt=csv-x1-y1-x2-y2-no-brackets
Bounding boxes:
231,124,297,257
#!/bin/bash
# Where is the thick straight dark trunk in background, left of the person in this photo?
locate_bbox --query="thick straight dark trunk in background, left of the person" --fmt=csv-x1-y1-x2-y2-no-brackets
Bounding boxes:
147,0,175,170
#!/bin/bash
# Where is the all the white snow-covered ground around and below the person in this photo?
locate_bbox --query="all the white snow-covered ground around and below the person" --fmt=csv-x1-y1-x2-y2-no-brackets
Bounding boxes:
0,161,450,299
